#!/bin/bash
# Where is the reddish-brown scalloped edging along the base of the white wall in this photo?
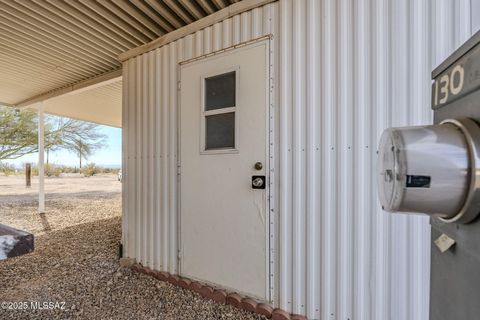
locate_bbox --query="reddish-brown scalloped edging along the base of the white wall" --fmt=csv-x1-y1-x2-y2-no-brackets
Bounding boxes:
132,263,307,320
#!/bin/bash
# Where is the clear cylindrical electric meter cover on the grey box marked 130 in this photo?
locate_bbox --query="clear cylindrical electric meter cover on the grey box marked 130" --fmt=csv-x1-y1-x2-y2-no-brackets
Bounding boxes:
378,123,471,219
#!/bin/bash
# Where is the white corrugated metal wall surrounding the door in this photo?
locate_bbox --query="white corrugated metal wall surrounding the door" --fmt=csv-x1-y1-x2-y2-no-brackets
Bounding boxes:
123,0,476,320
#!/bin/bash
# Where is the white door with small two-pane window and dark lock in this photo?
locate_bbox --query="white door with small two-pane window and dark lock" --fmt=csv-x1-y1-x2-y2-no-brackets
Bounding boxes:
179,41,269,300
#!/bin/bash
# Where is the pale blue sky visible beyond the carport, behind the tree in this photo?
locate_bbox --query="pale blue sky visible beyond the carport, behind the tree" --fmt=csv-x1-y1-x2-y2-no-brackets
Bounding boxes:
5,126,122,168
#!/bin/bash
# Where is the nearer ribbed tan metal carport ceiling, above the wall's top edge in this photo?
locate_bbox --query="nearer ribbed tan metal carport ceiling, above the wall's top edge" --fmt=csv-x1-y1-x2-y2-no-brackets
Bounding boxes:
0,0,238,112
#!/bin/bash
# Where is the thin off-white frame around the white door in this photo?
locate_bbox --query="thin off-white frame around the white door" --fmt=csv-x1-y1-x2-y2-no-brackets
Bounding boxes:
177,34,276,304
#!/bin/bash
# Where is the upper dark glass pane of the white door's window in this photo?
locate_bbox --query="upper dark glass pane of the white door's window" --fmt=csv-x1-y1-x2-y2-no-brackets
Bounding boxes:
205,71,236,111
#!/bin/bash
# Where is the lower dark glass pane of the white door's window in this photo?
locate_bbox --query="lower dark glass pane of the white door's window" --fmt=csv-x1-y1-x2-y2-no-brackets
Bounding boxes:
205,112,235,150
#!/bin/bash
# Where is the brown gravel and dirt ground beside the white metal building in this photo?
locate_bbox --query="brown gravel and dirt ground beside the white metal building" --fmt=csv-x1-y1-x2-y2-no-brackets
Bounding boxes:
0,177,263,320
